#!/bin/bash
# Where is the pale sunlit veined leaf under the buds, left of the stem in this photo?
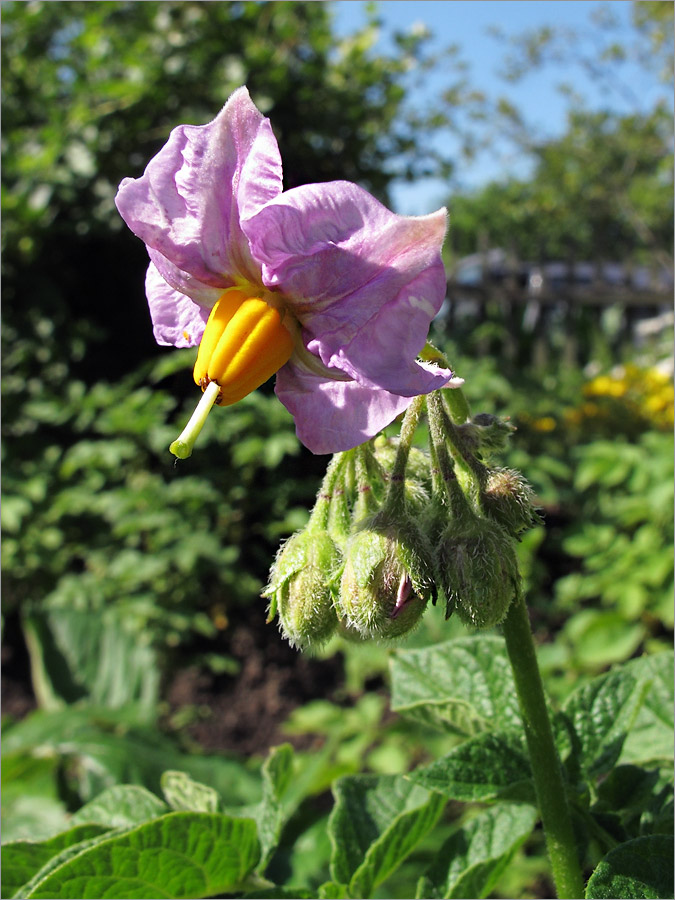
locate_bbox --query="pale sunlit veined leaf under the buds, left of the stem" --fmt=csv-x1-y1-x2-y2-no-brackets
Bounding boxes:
391,635,520,736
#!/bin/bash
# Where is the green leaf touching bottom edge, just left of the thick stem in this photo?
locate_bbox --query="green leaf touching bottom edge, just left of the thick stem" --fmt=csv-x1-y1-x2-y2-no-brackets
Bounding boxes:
417,804,537,898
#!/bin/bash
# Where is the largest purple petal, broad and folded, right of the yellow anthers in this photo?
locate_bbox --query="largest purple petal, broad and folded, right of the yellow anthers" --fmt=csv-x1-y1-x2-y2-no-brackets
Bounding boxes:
242,181,451,396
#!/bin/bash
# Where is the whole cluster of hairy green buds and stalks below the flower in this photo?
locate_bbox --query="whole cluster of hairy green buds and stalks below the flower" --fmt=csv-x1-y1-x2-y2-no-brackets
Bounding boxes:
263,384,538,650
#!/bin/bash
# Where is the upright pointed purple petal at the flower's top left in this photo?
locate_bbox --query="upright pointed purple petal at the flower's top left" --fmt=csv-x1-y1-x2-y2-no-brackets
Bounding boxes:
115,88,281,289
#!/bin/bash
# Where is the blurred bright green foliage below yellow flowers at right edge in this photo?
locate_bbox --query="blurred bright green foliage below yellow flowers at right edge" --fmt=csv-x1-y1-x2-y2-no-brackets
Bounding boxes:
555,432,673,668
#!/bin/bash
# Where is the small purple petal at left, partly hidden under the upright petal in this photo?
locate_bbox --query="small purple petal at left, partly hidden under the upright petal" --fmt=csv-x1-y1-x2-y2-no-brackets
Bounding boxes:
145,263,210,347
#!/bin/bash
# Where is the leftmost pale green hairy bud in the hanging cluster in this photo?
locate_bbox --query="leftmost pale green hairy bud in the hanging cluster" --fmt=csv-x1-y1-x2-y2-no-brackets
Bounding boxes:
263,527,342,650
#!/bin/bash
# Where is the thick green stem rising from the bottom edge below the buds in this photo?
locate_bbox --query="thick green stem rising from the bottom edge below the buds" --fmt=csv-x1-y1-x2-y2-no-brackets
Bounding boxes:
503,596,584,900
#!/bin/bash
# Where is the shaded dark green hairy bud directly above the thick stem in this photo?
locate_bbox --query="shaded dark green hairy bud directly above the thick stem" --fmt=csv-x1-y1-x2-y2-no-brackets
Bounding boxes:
438,519,520,628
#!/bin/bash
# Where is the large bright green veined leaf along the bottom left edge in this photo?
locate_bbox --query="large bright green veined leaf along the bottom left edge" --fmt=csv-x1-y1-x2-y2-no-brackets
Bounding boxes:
27,812,259,900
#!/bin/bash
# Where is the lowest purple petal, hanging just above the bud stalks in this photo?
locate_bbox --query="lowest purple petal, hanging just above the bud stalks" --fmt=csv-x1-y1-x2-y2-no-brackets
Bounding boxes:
275,361,410,453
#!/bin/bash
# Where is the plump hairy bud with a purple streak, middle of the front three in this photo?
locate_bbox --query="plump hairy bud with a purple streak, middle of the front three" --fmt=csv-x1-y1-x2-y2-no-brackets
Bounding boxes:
338,515,432,639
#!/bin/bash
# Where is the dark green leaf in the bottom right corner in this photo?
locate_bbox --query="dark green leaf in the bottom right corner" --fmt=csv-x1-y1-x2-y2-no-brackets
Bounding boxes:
586,834,673,900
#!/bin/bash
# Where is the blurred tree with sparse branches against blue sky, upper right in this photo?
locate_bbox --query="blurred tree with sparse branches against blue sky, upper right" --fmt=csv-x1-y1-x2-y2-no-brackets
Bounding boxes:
449,2,673,267
